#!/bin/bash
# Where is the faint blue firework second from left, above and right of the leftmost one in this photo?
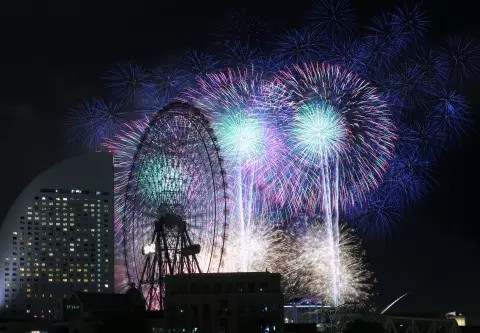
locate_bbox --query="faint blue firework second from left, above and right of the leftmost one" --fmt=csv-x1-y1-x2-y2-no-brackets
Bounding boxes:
103,61,151,103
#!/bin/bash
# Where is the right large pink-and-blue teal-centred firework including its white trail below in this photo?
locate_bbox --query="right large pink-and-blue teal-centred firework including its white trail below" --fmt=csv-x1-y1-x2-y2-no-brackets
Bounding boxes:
269,63,396,304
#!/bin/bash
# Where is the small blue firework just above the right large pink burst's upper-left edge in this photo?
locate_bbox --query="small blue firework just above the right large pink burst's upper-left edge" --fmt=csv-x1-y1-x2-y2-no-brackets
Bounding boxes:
275,28,325,64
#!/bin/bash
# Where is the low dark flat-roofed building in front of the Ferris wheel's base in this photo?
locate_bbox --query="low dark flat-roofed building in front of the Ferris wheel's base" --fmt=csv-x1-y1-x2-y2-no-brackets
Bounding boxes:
165,272,283,333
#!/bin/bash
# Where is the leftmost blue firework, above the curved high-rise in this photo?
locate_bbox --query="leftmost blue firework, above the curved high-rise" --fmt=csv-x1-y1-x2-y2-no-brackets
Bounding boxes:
64,98,125,150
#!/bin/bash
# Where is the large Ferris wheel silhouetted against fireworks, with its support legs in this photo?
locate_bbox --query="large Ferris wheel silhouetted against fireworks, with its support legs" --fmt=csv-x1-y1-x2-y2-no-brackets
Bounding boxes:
122,103,227,309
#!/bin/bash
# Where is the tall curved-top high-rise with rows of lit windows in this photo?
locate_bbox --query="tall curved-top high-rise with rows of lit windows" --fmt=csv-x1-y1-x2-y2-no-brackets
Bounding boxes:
0,153,114,319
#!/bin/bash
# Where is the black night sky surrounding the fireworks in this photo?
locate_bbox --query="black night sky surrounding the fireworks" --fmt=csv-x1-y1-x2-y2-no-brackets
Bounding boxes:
0,0,480,312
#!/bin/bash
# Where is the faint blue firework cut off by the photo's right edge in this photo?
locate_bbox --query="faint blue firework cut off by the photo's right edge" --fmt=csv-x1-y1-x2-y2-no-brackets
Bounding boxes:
440,36,480,83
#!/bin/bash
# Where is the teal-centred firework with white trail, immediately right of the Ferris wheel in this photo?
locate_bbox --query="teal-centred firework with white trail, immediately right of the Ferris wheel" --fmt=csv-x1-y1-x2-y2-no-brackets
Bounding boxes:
184,68,286,271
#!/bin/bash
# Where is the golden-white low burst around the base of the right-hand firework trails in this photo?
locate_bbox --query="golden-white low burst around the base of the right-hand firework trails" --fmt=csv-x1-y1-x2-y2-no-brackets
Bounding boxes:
280,221,374,305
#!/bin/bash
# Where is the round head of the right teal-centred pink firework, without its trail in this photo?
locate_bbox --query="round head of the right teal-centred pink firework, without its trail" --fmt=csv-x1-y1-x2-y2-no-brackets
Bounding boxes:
271,63,396,209
